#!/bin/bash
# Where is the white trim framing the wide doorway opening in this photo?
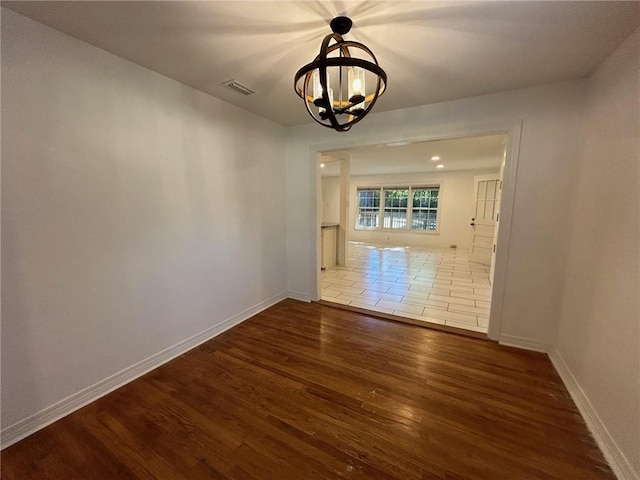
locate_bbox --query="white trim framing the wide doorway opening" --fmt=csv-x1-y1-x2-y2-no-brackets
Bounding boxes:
309,119,523,341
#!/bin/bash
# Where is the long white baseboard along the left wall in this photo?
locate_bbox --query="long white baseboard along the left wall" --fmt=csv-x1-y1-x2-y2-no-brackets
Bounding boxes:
0,293,287,449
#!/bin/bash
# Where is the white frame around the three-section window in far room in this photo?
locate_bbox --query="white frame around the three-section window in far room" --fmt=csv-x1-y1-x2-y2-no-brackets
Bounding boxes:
353,182,443,235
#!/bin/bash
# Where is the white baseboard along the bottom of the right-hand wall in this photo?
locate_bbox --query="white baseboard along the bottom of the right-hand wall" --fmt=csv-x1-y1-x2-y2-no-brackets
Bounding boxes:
549,348,640,480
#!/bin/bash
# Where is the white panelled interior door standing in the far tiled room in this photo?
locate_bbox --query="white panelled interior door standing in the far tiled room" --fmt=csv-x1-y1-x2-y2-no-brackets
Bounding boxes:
469,173,500,266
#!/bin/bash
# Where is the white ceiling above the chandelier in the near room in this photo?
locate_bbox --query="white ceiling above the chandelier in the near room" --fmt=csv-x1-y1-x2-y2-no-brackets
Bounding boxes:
2,0,640,126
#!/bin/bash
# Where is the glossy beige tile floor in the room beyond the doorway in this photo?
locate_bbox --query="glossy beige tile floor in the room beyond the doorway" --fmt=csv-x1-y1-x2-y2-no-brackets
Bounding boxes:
321,242,491,333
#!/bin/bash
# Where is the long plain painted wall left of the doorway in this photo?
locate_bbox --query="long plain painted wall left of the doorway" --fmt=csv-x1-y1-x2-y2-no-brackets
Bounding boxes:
2,8,286,428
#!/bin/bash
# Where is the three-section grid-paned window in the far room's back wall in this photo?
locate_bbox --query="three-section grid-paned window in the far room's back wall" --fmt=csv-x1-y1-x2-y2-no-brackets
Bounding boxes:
356,186,440,232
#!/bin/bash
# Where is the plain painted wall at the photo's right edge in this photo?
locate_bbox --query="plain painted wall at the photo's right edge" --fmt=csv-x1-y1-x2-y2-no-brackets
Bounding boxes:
555,30,640,478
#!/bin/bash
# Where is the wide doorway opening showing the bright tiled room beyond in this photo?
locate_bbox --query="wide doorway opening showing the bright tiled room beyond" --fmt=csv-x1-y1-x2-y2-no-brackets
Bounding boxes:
318,128,519,337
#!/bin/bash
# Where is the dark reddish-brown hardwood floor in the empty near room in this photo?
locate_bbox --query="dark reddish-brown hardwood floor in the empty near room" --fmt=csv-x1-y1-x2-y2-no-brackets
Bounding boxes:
2,300,614,480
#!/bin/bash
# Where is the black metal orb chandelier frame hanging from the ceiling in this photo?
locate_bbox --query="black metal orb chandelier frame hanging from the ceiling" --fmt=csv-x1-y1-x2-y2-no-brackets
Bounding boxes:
294,17,387,132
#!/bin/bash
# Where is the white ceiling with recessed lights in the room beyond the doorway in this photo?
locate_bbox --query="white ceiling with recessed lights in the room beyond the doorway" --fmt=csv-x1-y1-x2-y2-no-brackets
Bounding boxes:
320,135,504,177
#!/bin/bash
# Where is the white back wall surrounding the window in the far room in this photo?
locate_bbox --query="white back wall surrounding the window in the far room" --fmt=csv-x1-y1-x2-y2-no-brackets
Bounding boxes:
344,168,500,248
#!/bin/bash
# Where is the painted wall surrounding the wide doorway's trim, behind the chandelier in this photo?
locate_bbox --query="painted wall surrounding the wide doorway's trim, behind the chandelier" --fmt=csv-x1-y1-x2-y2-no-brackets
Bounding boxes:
287,81,586,348
